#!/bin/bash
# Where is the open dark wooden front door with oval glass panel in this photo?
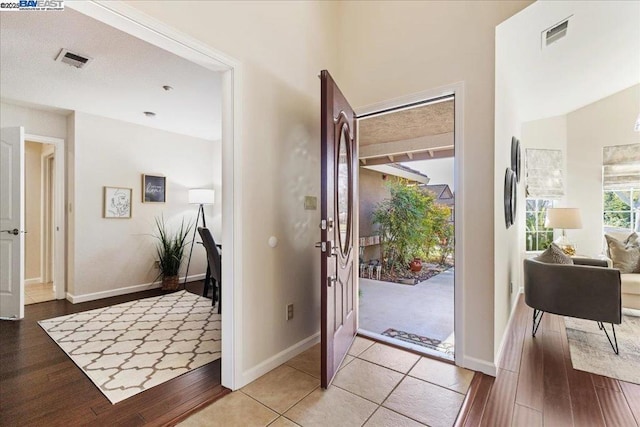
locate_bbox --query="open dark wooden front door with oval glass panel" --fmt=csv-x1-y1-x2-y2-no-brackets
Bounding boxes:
320,70,358,388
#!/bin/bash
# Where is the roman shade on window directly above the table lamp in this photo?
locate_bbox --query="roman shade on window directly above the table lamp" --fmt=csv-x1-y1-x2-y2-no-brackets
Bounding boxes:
525,148,564,200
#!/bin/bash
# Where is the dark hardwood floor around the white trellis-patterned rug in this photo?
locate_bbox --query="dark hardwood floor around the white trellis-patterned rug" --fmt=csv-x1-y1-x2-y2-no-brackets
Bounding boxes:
0,282,229,426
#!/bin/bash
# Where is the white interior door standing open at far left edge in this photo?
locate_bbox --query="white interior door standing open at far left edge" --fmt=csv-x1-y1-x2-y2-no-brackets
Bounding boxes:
0,127,24,319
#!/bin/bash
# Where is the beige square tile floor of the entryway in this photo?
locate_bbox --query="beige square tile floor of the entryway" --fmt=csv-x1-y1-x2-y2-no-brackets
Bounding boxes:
180,337,473,427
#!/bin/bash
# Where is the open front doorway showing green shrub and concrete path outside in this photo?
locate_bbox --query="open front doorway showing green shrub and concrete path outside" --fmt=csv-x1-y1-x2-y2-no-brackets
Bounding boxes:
358,95,455,360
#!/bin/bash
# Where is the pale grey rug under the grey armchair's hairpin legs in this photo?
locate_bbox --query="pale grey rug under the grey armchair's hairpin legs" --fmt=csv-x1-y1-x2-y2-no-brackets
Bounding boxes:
564,308,640,384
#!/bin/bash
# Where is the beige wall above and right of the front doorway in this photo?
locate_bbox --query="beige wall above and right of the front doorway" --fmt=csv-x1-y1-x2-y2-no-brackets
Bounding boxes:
334,1,529,371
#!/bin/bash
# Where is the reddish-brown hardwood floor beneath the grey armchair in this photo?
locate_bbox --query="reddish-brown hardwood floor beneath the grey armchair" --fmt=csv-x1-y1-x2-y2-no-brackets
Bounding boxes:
456,296,640,427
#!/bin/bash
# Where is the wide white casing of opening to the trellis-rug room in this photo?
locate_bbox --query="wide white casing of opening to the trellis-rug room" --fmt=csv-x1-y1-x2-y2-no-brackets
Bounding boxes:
65,1,243,390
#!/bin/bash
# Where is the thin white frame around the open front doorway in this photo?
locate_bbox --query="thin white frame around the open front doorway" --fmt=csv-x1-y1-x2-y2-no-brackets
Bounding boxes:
355,82,466,366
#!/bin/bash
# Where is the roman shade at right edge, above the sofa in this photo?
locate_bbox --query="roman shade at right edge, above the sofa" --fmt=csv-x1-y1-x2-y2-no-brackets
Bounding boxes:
602,144,640,190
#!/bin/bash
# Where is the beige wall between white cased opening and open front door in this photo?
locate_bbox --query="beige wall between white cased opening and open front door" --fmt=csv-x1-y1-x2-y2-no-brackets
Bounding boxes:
128,1,337,386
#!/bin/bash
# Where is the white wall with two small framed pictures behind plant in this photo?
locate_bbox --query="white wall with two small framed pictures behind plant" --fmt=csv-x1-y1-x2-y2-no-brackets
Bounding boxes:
68,112,221,301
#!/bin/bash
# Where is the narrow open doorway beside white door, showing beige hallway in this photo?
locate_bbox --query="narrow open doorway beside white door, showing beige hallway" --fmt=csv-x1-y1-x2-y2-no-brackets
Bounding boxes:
24,140,57,305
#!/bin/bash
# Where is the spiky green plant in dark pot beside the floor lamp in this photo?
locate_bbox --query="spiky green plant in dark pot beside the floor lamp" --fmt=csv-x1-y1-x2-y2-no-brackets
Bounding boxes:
154,217,191,291
